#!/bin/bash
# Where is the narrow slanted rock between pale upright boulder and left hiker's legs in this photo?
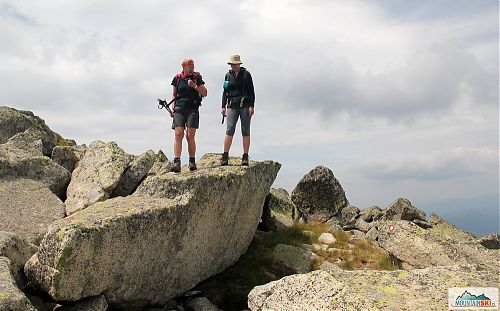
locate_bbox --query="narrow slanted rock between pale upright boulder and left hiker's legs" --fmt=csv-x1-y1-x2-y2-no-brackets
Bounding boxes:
111,150,164,197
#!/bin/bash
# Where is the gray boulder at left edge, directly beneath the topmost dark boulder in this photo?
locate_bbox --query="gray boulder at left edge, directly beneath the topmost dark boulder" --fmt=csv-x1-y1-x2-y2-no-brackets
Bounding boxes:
0,143,70,197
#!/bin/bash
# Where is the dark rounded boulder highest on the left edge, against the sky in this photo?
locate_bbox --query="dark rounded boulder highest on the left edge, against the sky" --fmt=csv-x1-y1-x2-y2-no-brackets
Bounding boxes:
0,106,65,156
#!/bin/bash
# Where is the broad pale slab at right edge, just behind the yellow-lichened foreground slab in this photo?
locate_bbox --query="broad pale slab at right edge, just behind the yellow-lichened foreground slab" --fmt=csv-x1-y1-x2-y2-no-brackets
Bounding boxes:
377,220,500,270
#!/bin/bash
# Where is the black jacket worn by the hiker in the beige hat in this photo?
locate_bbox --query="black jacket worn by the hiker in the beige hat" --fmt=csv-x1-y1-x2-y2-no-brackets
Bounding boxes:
222,67,255,107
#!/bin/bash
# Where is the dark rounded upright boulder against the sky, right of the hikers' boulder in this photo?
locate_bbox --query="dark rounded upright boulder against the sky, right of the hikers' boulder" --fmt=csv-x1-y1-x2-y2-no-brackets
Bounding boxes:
292,166,349,222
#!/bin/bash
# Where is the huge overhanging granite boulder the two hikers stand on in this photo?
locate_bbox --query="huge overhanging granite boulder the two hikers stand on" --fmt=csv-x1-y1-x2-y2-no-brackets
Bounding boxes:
25,157,280,307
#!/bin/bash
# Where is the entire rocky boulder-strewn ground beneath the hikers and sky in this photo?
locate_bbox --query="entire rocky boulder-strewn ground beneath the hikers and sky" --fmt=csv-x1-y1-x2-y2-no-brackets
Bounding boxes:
0,107,500,311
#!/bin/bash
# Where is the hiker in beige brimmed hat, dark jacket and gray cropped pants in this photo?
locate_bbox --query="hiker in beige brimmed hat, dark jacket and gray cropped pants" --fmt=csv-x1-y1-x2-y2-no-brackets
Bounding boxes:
221,55,255,166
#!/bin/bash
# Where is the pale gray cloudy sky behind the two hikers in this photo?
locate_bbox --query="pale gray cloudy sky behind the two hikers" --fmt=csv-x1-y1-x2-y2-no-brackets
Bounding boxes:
0,0,499,235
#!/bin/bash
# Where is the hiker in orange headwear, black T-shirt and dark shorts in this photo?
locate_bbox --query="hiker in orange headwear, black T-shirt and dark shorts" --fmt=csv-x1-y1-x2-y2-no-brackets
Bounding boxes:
171,58,207,173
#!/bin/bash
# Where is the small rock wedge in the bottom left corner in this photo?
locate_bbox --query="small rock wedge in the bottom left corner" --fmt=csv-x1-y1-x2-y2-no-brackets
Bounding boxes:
0,258,37,311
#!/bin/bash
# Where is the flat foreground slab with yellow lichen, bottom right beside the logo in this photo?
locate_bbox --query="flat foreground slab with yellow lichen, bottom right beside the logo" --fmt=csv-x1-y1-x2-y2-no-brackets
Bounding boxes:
248,265,498,311
